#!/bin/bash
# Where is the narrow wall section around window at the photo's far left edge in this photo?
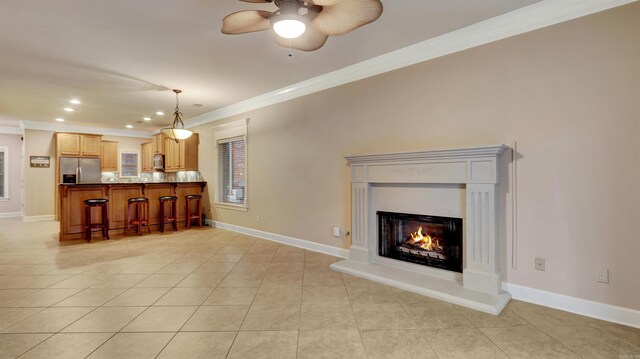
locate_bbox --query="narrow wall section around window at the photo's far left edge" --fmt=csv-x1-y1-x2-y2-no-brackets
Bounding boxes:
0,133,22,215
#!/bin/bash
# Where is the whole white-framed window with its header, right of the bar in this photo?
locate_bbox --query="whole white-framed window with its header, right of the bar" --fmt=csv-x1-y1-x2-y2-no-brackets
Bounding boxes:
213,119,249,211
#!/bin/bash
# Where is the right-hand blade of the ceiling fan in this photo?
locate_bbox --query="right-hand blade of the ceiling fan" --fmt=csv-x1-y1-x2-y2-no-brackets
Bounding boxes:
311,0,382,35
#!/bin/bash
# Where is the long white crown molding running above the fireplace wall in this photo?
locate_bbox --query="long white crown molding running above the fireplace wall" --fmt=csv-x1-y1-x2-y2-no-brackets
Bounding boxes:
185,0,637,128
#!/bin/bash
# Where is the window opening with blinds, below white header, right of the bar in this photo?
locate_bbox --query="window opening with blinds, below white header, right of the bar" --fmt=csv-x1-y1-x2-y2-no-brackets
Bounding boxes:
218,137,245,204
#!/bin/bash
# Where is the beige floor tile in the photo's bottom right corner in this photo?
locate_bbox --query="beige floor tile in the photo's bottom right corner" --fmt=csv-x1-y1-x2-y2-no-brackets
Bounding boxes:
540,326,640,359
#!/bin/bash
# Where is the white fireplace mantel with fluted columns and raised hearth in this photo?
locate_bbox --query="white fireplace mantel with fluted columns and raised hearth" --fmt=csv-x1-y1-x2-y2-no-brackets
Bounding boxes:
331,145,511,314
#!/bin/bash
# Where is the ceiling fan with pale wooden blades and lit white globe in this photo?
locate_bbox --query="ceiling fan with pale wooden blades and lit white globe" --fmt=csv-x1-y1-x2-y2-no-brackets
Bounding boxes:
222,0,382,51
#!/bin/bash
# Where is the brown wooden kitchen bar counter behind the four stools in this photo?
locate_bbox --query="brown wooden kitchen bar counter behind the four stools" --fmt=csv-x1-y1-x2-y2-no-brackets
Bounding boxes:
59,182,207,241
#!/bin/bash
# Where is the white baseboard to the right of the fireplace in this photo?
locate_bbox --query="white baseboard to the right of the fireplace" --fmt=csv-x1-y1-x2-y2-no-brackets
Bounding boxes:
502,282,640,328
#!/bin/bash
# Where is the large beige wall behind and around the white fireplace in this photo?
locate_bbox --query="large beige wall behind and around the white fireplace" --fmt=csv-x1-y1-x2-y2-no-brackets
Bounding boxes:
196,3,640,309
